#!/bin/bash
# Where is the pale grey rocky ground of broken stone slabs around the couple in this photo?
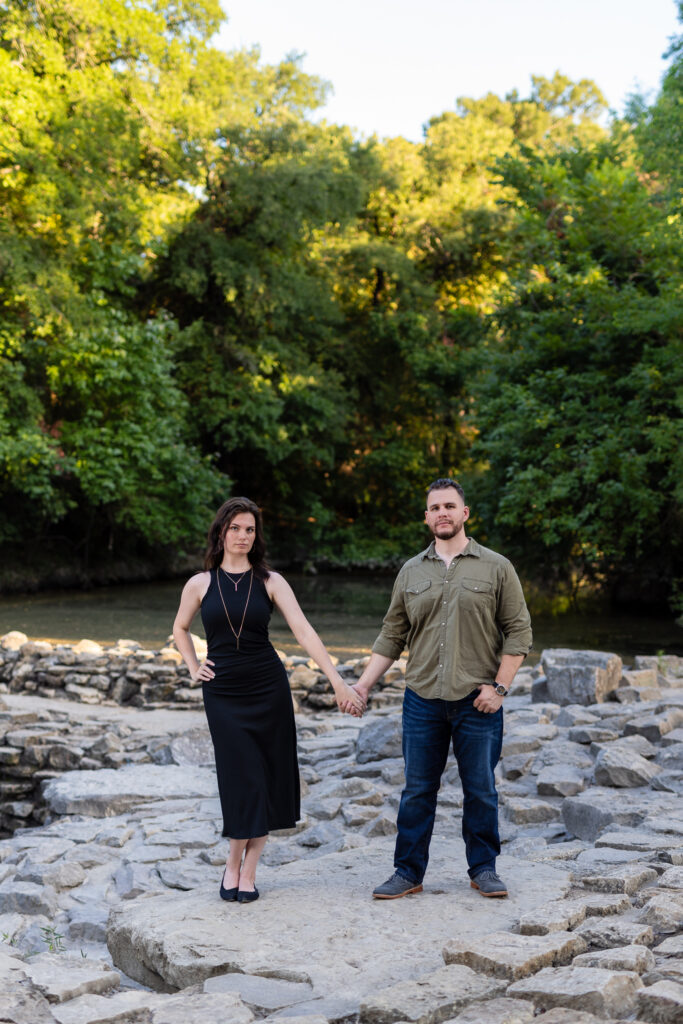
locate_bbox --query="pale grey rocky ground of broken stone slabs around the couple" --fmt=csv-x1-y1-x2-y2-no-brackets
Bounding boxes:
0,651,683,1024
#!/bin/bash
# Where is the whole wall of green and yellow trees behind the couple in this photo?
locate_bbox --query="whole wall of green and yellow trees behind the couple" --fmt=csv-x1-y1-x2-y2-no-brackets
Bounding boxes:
0,0,683,605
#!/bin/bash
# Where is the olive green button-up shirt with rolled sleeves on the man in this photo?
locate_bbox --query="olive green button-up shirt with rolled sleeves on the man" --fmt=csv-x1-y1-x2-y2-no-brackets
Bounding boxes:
373,539,531,700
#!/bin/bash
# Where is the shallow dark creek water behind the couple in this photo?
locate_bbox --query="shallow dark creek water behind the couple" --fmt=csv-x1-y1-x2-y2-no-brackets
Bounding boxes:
0,573,683,663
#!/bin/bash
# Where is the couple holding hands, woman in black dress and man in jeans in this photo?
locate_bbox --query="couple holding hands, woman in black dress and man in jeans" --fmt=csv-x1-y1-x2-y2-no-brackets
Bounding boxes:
173,478,531,903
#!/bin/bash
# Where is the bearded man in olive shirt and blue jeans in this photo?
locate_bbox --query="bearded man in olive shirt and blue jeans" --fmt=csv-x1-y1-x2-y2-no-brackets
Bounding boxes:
354,478,531,899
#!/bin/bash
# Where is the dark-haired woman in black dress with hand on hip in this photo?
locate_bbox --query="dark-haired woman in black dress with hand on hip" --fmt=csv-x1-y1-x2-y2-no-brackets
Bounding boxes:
173,498,365,903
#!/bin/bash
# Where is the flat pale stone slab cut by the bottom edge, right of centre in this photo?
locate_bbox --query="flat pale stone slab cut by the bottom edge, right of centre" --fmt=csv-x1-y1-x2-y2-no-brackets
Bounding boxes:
359,965,505,1024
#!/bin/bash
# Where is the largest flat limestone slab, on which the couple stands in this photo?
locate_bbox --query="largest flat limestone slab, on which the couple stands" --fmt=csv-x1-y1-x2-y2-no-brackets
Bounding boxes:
108,835,568,1009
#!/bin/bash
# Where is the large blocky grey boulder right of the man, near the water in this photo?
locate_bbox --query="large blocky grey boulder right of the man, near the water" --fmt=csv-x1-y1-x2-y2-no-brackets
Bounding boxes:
541,647,623,705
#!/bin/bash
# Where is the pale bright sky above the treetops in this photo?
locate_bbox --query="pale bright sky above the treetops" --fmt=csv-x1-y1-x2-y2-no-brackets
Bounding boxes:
216,0,683,141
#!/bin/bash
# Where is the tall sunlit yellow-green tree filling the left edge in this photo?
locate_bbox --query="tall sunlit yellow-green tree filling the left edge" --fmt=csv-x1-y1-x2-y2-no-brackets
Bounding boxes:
0,0,325,569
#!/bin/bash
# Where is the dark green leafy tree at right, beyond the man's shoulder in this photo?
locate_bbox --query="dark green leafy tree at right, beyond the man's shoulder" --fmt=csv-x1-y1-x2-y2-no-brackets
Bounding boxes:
472,145,683,599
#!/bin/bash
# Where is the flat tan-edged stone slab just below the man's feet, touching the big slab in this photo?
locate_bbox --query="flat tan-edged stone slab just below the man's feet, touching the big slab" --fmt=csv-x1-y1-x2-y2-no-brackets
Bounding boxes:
442,932,587,981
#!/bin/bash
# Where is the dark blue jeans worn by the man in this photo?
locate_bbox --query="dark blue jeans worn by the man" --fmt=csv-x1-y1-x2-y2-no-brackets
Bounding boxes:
394,689,503,884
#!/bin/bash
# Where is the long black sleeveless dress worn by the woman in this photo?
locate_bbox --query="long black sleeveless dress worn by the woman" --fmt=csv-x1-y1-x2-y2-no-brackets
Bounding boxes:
202,568,300,839
